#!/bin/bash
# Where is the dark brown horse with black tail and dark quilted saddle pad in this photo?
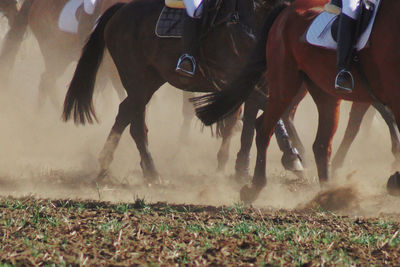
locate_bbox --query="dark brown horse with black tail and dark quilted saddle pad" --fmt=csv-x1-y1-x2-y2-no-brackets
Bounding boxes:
63,0,288,182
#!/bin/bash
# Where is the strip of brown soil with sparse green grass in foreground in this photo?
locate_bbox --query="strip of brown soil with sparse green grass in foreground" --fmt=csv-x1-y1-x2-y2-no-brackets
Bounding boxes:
0,198,400,266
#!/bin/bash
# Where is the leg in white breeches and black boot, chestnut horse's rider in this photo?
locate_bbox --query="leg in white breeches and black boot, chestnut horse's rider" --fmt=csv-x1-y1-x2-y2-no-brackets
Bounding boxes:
335,0,360,93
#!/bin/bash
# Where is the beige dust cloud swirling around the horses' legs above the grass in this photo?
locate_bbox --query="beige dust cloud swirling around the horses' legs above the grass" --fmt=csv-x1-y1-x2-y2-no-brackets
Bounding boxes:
0,19,400,218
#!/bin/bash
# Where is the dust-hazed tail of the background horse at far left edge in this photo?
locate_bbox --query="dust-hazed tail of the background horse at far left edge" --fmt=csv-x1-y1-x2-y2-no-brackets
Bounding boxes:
0,0,35,77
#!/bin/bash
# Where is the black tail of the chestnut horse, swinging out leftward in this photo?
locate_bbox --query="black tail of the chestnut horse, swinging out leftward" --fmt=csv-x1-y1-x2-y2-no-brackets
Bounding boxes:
191,4,287,125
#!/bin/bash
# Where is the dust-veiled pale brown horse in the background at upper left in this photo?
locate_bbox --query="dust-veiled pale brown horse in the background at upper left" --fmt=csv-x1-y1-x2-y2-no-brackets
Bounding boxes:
0,0,128,109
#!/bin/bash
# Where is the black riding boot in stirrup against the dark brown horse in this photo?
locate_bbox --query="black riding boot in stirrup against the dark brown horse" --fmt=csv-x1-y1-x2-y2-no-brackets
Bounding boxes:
175,16,201,77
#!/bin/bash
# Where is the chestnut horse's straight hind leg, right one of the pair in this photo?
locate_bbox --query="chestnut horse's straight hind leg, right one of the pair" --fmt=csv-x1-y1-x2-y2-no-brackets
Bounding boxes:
306,80,340,186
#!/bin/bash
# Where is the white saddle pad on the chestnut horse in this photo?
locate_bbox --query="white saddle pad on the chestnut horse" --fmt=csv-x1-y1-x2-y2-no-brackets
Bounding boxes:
306,0,381,50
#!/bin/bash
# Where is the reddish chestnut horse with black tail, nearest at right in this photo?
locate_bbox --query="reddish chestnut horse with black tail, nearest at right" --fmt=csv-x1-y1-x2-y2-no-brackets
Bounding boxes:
193,0,400,202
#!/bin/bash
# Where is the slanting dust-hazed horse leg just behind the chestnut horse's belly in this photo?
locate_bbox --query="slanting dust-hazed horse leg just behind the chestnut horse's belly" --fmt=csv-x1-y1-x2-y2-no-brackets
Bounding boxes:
332,102,370,176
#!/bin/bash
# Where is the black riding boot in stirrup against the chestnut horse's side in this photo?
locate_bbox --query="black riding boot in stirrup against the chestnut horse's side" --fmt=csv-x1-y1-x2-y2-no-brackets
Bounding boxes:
335,13,357,93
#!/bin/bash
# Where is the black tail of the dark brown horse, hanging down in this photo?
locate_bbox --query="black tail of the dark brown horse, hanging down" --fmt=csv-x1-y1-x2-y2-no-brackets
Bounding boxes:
62,3,125,124
